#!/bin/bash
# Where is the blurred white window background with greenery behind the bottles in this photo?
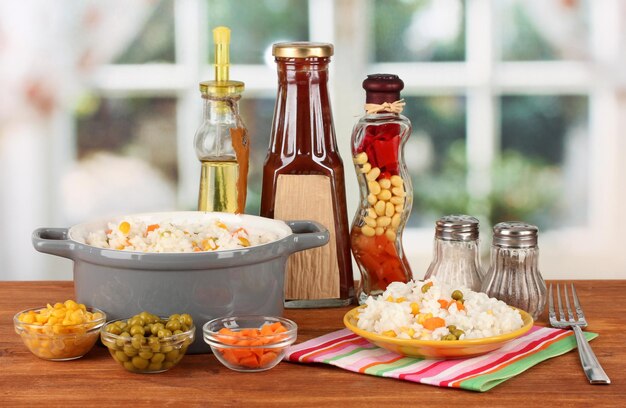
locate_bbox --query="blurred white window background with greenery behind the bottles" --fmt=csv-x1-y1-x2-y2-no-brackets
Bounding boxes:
0,0,626,279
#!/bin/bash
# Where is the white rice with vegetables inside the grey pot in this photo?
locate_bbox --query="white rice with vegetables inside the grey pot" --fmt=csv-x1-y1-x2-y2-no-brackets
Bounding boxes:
86,218,278,252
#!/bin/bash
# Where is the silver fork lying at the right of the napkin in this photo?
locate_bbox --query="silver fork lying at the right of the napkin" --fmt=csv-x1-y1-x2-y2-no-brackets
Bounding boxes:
548,283,611,384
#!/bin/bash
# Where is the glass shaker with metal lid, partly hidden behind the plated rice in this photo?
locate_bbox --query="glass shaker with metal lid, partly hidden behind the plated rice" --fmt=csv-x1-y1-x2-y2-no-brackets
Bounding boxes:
424,215,482,291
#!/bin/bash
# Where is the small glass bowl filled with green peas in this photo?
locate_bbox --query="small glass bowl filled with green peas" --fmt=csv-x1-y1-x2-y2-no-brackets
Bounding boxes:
100,312,196,373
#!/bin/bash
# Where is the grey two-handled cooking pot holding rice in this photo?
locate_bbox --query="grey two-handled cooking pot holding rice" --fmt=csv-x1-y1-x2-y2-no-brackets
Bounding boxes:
33,212,328,353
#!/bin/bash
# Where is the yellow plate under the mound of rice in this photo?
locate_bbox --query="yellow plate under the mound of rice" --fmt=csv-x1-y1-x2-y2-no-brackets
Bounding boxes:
343,306,533,359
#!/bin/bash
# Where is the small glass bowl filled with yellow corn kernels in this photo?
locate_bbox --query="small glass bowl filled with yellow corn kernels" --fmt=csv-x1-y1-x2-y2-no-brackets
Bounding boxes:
13,300,106,361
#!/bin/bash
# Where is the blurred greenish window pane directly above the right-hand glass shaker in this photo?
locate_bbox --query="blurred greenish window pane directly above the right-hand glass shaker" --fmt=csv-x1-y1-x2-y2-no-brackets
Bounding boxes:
491,95,589,228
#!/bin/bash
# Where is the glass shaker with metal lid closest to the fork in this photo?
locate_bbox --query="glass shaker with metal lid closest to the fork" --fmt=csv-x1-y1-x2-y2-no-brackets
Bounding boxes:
482,221,546,320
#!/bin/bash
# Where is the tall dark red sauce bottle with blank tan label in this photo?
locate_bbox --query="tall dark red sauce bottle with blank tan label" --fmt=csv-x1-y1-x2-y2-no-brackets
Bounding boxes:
261,42,354,308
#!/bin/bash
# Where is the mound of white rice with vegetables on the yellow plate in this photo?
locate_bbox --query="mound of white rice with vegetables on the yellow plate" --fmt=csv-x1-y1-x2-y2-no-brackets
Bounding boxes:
357,279,524,340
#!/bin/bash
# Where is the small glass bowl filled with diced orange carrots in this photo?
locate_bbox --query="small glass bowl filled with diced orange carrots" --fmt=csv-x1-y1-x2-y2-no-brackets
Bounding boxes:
202,316,298,372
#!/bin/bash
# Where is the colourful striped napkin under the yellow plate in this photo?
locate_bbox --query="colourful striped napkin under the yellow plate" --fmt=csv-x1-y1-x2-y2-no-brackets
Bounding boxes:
285,326,598,392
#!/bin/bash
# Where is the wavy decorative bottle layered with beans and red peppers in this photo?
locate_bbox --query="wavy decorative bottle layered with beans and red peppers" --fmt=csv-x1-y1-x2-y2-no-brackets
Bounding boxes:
350,74,413,303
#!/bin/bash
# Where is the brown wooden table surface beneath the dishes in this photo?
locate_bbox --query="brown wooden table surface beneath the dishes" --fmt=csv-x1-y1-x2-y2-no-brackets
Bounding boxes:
0,281,626,407
